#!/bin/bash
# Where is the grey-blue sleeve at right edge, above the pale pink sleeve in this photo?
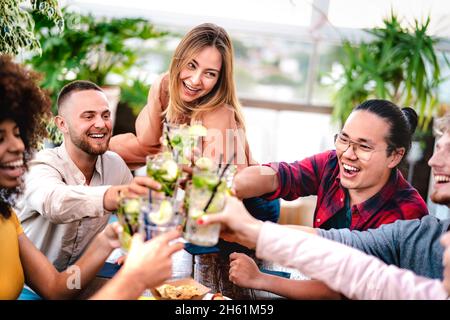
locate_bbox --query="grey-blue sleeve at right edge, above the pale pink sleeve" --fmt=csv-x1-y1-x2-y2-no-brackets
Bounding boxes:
317,216,450,280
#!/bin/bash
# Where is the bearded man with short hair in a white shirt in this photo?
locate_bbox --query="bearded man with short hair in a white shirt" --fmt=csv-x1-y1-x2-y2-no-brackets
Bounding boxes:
17,81,159,270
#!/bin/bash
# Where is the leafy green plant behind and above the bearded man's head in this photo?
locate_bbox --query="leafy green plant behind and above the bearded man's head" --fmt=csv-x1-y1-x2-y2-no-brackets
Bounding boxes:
29,9,166,112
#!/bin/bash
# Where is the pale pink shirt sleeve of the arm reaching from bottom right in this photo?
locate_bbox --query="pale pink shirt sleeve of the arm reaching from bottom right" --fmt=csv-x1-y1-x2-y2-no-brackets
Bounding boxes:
256,222,449,300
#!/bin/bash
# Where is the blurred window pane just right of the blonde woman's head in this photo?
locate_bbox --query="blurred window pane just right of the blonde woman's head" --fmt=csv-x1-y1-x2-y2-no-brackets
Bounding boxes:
233,35,312,102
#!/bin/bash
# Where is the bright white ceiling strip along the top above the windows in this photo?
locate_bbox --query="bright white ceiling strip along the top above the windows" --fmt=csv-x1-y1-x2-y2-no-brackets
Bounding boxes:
64,0,450,38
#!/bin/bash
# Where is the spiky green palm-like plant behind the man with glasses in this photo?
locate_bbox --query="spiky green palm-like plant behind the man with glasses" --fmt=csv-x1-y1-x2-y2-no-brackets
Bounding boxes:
333,13,448,131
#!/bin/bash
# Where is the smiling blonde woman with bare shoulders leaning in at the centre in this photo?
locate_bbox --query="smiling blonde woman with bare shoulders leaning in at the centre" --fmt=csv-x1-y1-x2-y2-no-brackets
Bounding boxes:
110,23,279,221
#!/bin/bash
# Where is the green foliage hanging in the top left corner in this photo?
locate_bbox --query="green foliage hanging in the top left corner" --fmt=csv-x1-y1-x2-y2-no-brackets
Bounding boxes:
0,0,64,55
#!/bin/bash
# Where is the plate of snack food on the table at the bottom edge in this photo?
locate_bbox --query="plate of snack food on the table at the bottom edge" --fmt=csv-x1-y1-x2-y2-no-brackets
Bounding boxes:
151,278,211,300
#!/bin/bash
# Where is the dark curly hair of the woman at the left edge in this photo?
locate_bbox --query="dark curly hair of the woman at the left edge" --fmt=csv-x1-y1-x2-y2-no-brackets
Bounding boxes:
0,55,51,218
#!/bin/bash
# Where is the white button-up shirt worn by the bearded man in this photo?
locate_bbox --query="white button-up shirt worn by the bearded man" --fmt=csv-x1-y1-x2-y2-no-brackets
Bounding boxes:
17,144,133,270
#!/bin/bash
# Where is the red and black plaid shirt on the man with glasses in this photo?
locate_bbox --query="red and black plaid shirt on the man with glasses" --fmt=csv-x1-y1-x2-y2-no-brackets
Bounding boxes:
264,150,428,230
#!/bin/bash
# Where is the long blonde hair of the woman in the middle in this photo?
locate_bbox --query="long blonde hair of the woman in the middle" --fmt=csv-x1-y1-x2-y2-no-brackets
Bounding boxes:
164,23,245,129
